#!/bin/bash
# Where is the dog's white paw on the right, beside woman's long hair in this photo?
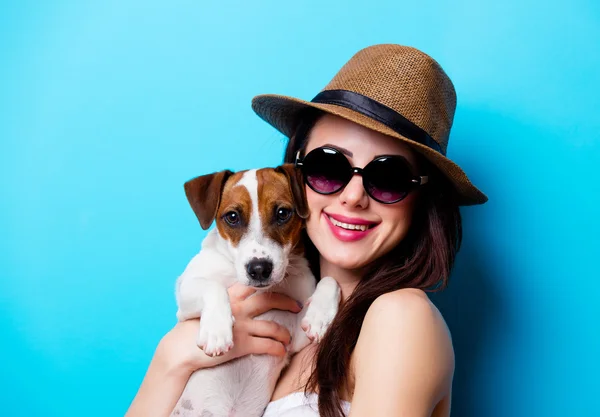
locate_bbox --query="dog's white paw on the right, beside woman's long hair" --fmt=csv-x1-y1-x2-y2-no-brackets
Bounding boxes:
301,277,341,343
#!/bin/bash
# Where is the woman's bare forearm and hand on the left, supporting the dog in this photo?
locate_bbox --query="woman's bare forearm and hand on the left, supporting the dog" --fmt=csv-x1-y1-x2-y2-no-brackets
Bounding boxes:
126,285,301,417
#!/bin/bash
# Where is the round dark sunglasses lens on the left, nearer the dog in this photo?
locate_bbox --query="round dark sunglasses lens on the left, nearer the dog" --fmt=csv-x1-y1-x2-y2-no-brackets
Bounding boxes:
302,148,350,194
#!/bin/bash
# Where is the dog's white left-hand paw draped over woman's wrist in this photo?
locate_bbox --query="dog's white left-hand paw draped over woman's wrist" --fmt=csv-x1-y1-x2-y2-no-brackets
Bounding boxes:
196,314,234,356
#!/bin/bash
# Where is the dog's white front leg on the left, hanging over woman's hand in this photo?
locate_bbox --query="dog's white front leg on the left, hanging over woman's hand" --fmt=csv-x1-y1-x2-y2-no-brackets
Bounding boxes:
177,276,234,356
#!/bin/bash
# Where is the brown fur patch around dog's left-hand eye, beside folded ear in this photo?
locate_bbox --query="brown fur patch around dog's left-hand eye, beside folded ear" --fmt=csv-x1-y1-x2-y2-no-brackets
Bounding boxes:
217,171,252,247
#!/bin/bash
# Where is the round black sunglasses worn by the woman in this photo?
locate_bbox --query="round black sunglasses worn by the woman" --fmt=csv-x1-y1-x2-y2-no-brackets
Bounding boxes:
295,146,429,204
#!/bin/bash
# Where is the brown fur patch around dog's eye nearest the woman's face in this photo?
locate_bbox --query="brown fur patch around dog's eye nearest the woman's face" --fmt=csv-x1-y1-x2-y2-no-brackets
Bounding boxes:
256,167,306,247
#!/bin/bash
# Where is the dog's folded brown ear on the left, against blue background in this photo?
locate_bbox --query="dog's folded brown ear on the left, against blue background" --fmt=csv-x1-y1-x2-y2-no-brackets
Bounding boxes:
183,170,233,230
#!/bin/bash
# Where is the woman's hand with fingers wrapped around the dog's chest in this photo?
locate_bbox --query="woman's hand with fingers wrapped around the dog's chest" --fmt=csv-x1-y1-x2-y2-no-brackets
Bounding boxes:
156,284,301,374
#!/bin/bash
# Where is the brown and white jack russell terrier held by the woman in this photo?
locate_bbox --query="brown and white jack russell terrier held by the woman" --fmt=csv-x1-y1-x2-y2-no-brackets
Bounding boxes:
171,164,340,417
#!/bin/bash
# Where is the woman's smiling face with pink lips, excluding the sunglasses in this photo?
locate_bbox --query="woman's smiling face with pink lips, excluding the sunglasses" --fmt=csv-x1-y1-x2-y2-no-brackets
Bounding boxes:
304,114,418,270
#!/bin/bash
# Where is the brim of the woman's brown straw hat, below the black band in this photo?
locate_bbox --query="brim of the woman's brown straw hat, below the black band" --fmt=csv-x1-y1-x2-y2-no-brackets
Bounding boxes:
252,94,488,206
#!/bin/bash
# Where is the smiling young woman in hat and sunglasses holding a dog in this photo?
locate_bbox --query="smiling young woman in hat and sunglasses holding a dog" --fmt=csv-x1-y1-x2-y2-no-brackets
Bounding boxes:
128,45,487,417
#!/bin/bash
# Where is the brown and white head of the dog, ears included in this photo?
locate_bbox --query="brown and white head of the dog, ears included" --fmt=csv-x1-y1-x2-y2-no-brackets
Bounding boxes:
185,164,308,288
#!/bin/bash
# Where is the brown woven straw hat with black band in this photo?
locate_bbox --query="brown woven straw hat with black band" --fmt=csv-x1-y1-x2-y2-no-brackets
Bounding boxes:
252,44,487,205
